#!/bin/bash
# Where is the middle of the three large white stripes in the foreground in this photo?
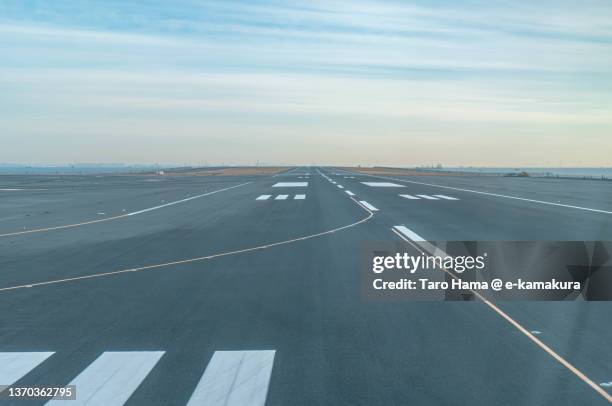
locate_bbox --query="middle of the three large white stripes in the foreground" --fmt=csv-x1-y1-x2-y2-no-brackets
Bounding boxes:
47,351,164,406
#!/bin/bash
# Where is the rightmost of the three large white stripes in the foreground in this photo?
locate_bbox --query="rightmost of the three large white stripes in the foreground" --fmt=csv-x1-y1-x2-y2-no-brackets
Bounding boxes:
187,350,276,406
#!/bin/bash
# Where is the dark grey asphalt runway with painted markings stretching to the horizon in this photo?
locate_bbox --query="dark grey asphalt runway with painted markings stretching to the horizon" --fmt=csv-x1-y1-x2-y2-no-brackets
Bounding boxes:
0,167,612,405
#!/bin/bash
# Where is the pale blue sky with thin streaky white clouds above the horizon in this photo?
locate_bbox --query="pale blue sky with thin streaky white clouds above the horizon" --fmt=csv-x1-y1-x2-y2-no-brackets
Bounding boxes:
0,0,612,167
